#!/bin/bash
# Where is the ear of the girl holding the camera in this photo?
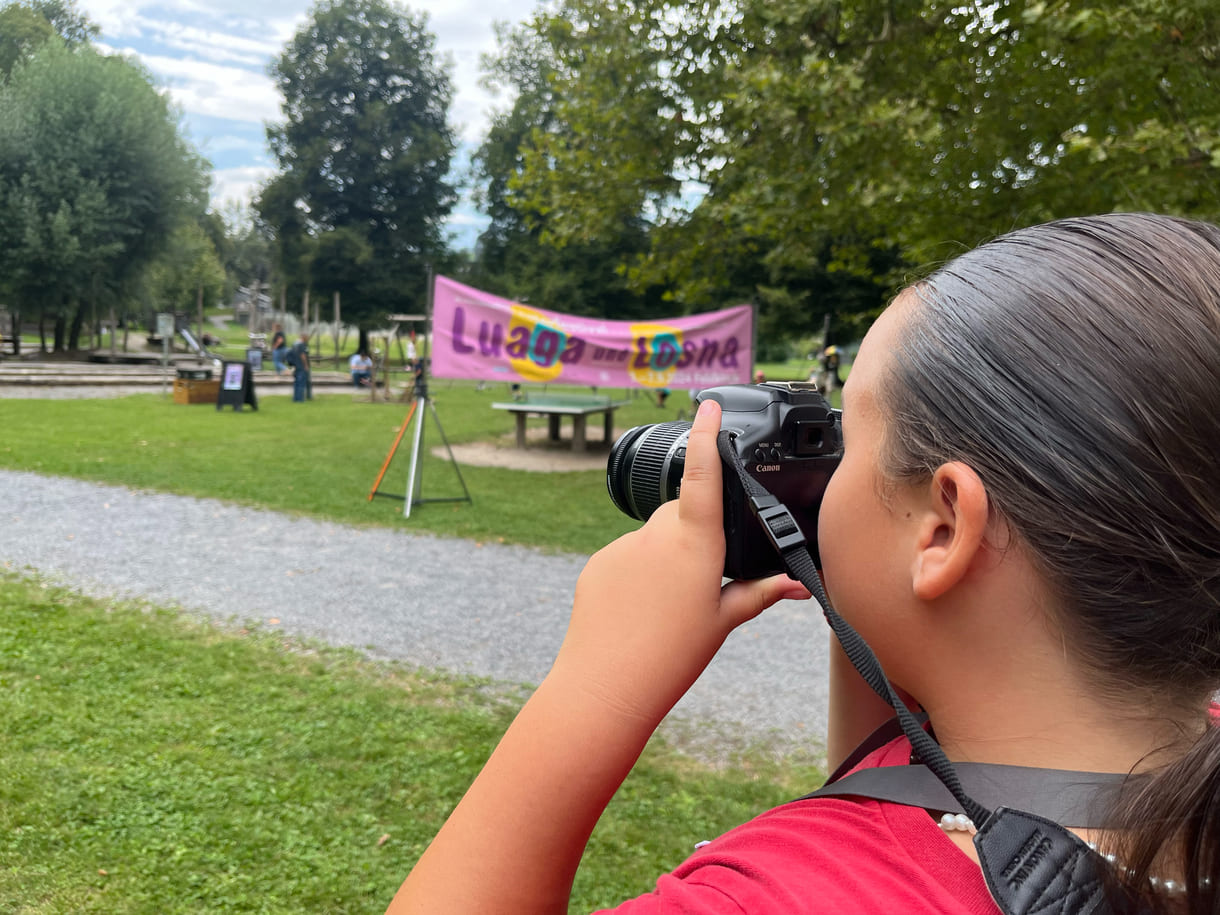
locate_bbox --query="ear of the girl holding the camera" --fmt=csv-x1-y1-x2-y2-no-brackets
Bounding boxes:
911,461,989,600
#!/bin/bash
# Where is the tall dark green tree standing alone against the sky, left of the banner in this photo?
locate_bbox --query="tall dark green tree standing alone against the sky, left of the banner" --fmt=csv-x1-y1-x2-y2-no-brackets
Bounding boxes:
257,0,454,329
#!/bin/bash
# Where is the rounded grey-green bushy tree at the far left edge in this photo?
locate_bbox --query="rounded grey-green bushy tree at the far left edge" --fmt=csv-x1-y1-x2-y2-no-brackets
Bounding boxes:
0,38,207,349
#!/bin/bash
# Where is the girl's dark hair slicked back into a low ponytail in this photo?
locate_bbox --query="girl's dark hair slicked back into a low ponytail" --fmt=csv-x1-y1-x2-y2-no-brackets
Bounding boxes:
882,214,1220,913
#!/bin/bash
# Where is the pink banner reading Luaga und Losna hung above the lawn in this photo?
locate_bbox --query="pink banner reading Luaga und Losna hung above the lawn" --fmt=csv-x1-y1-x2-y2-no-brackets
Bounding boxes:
432,277,754,388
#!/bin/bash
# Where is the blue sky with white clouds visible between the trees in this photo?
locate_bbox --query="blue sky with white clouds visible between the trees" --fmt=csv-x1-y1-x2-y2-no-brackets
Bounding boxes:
77,0,536,248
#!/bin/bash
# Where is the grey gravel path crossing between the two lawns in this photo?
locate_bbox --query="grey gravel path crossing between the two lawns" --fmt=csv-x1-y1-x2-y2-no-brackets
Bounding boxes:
0,471,827,759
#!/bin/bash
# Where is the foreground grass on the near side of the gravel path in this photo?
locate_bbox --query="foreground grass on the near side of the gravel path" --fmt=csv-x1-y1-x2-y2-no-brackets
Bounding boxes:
0,575,820,915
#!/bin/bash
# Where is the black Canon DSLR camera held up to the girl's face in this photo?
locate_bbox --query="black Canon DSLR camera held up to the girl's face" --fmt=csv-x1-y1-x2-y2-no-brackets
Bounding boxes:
606,382,843,578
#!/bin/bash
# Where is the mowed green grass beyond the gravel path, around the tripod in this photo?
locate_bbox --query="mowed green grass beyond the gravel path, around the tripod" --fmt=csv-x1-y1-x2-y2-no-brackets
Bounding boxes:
0,382,689,553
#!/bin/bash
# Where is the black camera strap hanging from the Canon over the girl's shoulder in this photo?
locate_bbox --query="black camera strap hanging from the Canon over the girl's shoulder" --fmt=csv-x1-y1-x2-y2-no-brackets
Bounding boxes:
716,429,1132,915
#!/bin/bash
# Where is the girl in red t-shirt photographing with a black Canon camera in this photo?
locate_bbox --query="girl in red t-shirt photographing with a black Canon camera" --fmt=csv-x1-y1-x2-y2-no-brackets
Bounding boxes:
389,214,1220,915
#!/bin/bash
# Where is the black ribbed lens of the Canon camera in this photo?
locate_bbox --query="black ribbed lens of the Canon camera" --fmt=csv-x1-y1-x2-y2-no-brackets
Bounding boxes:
606,420,691,521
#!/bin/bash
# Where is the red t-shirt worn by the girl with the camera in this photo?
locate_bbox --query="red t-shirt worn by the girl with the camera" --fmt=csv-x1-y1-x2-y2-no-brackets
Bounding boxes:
592,738,999,915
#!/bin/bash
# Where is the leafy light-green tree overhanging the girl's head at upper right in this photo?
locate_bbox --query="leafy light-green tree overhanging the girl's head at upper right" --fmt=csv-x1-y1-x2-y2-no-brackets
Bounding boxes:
495,0,1220,344
